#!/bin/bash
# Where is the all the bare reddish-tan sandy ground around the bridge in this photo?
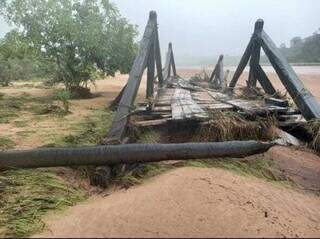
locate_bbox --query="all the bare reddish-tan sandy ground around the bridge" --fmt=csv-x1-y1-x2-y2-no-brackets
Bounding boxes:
0,69,320,237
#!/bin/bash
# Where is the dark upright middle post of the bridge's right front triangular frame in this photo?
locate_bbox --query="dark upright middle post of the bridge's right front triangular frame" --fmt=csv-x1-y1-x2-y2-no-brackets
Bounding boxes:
248,19,264,87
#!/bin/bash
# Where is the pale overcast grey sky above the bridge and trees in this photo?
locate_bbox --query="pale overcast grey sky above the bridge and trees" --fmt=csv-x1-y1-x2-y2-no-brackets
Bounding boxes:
0,0,320,57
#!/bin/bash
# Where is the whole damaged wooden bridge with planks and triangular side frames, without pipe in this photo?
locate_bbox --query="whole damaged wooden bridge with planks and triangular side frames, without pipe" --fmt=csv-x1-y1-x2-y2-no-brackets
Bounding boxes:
106,12,320,143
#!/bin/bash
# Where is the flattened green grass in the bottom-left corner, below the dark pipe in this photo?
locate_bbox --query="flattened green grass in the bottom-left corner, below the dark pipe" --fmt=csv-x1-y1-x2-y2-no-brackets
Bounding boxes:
0,170,87,237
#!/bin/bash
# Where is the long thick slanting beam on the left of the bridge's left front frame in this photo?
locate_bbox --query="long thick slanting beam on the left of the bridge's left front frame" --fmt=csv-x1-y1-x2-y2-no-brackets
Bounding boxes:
106,11,157,142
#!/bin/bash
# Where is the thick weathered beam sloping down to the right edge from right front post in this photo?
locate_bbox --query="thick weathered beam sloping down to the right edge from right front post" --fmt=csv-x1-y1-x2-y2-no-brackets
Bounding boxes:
260,31,320,120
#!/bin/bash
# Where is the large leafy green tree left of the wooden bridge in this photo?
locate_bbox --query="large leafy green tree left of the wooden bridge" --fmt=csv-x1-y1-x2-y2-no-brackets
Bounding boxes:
1,0,137,93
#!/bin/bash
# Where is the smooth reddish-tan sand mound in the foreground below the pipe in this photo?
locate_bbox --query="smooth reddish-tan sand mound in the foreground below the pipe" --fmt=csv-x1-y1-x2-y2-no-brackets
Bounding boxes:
37,168,320,237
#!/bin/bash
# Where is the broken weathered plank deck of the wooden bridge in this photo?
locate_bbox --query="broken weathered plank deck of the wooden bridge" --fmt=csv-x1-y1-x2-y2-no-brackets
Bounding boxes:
135,78,303,129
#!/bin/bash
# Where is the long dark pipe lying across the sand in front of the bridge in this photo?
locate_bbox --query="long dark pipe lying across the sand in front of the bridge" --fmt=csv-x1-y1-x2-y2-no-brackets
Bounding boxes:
0,141,276,170
